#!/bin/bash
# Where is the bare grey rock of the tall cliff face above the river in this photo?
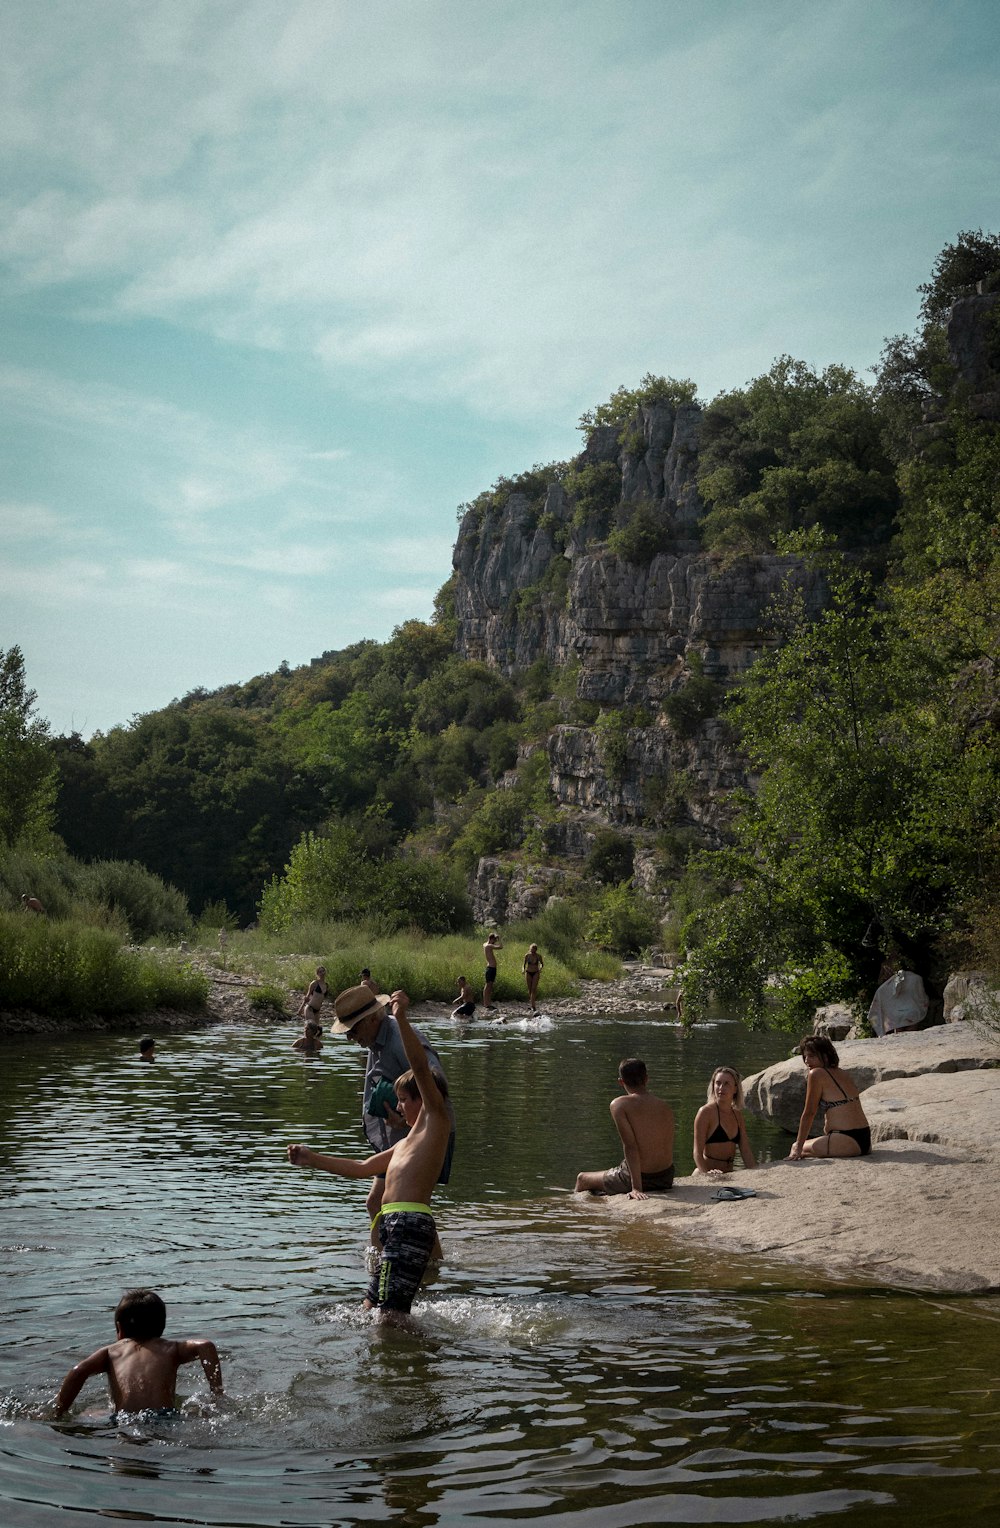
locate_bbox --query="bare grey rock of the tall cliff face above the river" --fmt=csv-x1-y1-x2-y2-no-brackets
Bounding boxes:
454,405,823,917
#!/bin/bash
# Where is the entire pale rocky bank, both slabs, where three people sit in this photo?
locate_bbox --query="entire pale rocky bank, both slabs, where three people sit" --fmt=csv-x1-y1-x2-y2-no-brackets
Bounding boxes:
609,1022,1000,1294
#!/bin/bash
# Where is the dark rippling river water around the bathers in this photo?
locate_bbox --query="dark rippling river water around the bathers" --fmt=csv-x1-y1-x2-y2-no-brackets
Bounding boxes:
0,1016,1000,1528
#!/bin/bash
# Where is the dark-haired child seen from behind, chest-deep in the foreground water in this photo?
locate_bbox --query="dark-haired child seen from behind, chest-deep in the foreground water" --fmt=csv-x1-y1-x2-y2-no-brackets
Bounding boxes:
55,1290,222,1413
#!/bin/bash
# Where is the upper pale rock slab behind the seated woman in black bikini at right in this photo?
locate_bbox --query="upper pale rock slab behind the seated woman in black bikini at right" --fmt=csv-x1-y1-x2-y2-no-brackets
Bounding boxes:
743,1022,1000,1131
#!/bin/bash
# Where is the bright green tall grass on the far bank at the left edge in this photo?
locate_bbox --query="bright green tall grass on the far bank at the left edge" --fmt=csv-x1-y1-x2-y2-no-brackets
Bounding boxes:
0,912,208,1016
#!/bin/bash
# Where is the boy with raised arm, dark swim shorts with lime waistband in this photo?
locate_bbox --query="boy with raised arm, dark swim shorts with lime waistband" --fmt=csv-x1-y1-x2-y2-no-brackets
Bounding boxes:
287,992,451,1320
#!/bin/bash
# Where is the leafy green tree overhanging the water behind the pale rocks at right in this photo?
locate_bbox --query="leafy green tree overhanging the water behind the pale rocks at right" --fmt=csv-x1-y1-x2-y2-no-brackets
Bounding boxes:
685,543,1000,1025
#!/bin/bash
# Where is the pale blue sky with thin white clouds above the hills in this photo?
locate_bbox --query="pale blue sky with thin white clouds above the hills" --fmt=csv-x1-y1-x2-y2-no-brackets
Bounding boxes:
0,0,1000,736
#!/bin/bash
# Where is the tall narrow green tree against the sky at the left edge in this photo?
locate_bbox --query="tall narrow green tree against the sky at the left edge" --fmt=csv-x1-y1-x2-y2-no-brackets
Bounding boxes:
0,646,57,848
